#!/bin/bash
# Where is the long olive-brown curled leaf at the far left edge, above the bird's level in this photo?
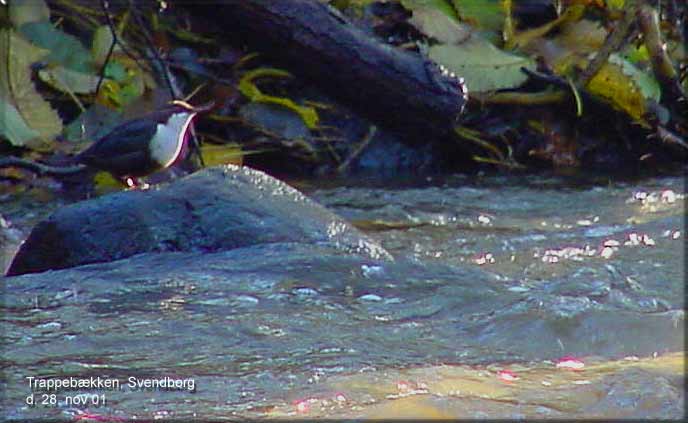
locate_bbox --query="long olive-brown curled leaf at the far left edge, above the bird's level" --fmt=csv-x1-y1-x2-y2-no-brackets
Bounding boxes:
0,29,62,149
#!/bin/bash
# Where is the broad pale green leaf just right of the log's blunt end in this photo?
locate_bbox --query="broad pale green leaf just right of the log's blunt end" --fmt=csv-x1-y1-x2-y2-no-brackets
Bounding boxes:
428,35,535,92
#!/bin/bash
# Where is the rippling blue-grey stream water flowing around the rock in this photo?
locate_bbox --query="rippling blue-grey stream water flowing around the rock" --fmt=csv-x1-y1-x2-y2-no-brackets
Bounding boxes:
0,171,686,420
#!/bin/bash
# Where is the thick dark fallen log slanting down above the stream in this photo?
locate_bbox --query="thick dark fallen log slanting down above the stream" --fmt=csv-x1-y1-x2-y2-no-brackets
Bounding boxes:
185,0,466,144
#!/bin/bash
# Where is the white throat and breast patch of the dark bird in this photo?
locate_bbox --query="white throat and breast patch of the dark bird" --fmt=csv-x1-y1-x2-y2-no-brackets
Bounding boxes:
149,112,196,168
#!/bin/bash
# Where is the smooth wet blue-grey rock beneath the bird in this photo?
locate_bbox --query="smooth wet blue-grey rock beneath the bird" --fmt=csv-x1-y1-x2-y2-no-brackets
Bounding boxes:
7,165,391,276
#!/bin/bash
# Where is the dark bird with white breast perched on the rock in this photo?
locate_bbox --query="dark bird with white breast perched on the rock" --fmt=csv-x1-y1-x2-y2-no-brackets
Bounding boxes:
74,100,214,188
